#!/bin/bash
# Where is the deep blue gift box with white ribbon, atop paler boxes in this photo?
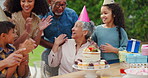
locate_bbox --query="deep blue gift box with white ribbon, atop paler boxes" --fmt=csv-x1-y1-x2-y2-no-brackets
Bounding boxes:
126,39,140,53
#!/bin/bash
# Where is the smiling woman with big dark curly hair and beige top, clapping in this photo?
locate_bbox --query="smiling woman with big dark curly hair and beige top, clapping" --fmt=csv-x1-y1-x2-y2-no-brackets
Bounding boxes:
4,0,51,48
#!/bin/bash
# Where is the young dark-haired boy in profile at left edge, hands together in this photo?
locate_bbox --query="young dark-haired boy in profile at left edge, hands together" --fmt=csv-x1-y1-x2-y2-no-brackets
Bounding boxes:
0,21,35,78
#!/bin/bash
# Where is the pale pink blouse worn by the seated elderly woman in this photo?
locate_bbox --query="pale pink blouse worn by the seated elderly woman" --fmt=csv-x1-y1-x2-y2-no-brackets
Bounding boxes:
48,39,90,75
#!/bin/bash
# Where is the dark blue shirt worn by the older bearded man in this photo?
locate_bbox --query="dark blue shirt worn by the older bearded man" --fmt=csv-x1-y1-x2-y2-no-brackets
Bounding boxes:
40,8,78,43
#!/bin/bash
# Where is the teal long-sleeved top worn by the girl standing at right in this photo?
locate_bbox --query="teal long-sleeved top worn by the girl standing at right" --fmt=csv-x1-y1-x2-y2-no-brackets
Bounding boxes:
92,25,128,60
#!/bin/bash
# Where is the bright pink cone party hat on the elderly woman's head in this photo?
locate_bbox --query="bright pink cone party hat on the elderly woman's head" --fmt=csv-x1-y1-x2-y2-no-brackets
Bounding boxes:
78,6,90,22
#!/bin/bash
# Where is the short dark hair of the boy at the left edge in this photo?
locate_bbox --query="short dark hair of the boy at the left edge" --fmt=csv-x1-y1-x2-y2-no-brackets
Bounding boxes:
0,21,15,35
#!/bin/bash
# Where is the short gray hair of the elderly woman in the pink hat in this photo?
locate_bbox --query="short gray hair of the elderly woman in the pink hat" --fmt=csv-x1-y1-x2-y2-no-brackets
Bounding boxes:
78,21,94,39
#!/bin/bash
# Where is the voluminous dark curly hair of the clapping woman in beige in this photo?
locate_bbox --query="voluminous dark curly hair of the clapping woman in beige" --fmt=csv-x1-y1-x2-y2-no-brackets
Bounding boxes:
4,0,49,15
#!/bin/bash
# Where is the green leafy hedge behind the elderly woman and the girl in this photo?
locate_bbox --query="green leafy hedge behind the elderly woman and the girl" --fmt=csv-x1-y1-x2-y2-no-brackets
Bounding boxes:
67,0,148,41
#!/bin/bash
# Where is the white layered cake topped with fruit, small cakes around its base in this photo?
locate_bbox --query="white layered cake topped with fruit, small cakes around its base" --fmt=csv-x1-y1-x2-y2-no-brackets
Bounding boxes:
75,45,107,69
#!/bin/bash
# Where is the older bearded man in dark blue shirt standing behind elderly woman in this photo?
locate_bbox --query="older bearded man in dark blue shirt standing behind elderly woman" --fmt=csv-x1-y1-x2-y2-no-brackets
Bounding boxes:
40,0,78,76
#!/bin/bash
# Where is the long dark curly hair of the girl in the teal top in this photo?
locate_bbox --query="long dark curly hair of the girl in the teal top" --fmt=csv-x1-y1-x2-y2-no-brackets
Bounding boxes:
103,3,125,39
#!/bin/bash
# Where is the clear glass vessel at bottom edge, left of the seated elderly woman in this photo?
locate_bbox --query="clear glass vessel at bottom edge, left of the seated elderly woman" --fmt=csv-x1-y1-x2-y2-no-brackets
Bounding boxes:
33,61,50,78
